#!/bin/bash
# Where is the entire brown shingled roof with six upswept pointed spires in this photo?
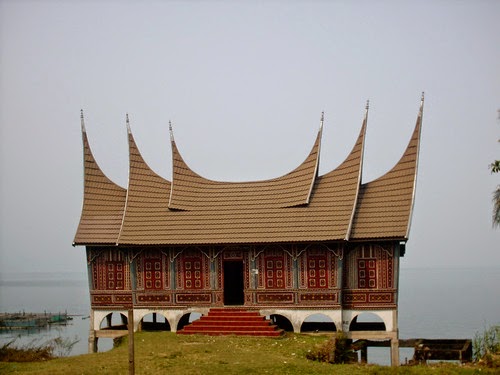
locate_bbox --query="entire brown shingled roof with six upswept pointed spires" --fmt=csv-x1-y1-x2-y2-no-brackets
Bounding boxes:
75,99,421,245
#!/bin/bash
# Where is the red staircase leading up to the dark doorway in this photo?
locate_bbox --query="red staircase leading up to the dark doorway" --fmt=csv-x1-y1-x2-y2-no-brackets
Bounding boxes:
177,308,284,337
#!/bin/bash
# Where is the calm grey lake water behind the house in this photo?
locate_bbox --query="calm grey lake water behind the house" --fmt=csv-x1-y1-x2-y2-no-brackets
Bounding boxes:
0,267,500,364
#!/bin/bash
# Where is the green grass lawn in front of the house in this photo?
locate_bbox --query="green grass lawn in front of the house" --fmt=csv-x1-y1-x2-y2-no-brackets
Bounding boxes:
0,332,493,375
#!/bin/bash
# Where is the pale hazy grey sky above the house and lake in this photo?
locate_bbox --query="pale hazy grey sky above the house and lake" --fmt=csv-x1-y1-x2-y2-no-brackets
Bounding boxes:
0,0,500,272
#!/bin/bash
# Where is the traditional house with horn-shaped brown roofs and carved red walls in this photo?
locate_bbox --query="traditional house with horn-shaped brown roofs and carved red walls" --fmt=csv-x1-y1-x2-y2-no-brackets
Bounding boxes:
73,96,423,364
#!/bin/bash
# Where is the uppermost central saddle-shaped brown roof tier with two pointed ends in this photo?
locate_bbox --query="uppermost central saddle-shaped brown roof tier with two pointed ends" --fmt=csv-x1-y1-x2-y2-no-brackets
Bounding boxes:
168,117,323,211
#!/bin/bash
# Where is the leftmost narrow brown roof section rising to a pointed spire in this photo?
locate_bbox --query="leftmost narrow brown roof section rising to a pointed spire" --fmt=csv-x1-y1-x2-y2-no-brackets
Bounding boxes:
73,111,127,245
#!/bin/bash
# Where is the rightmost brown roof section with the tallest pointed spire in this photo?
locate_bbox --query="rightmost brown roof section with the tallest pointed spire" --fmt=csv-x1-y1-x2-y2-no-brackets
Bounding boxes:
351,95,424,239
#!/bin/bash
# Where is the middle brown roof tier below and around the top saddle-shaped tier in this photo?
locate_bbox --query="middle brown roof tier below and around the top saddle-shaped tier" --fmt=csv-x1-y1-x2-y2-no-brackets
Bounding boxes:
117,114,365,245
